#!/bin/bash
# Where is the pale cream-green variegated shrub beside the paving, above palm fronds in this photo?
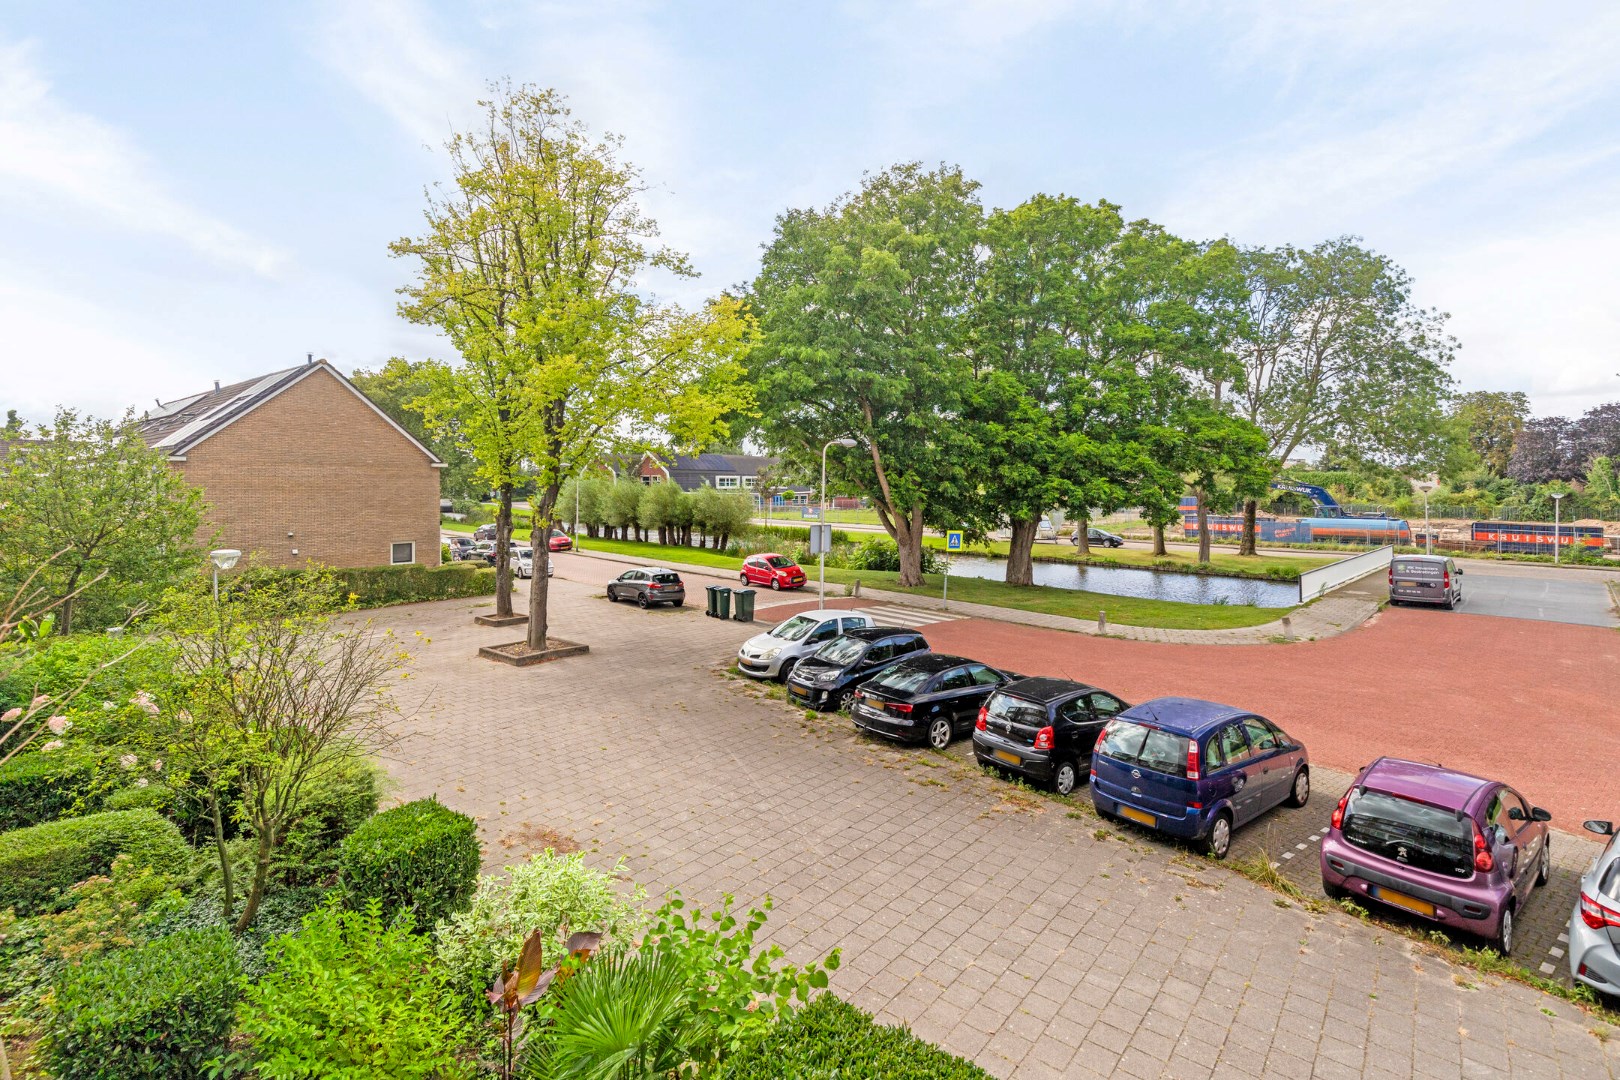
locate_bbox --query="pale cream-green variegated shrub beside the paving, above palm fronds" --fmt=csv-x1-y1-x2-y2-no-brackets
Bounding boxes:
436,850,646,996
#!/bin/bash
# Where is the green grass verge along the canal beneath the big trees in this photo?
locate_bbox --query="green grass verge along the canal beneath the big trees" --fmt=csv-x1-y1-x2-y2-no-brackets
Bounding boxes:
567,538,1290,630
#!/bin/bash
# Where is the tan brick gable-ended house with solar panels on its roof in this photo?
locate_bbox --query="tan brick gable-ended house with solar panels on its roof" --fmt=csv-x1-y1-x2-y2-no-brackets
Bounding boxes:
139,359,444,567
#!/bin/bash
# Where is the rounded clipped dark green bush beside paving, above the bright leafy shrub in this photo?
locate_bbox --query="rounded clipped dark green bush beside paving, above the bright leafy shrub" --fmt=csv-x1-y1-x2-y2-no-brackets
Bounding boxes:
337,798,483,929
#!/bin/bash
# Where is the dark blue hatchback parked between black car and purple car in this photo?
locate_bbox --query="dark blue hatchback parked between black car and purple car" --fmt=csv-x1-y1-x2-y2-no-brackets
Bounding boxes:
1092,698,1311,858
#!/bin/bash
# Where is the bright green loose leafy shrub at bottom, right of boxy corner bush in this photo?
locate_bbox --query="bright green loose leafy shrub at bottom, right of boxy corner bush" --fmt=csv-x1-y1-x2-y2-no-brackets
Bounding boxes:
237,900,471,1080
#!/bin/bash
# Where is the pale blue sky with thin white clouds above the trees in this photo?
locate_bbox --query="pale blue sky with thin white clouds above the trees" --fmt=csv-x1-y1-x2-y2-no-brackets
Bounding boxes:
0,0,1620,419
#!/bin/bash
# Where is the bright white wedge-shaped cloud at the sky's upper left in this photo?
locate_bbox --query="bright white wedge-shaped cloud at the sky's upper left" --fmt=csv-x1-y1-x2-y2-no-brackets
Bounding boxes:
0,42,285,275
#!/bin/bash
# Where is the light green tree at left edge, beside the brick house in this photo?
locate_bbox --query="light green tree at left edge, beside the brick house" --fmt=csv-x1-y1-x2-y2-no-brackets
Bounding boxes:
0,410,204,633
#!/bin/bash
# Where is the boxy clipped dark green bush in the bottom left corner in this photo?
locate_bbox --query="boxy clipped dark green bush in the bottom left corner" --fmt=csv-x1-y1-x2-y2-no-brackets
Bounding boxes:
44,929,240,1080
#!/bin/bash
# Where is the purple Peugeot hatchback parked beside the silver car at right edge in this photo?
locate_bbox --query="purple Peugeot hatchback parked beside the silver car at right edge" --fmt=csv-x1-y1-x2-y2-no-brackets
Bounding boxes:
1322,758,1548,955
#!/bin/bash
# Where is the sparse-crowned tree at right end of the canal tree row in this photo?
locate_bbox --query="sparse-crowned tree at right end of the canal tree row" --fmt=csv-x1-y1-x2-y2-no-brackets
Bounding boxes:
1226,236,1456,554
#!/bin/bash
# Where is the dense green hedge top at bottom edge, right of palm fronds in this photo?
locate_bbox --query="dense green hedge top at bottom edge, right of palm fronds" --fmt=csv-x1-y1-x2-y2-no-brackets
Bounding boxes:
718,994,990,1080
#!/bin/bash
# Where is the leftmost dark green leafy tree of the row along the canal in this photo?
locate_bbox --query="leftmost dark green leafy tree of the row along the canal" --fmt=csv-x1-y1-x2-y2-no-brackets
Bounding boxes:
752,162,983,586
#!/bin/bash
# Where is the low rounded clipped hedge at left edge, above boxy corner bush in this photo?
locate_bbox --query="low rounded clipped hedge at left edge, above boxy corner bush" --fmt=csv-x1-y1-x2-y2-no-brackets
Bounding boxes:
0,810,191,916
